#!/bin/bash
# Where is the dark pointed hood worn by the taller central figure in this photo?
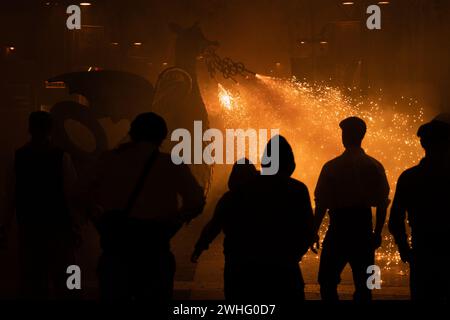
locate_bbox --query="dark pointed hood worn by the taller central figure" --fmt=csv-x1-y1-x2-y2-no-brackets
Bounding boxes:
261,135,295,177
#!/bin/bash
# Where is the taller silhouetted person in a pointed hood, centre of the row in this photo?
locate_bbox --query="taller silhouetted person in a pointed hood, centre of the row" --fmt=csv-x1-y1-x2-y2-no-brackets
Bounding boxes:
199,136,313,301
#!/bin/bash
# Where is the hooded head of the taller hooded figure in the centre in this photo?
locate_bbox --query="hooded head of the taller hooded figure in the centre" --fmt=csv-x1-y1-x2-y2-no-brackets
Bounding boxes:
261,135,295,177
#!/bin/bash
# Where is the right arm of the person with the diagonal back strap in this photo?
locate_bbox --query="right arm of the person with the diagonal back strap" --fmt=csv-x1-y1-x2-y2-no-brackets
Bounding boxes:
174,164,205,222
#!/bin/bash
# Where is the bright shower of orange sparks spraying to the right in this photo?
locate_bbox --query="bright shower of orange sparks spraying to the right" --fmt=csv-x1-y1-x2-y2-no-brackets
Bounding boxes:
205,74,424,269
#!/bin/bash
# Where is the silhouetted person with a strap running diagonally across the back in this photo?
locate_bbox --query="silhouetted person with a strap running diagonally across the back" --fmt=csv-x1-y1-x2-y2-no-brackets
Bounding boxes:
89,112,205,304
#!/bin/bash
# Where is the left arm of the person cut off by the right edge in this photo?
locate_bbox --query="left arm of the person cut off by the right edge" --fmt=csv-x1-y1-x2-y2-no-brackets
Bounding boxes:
388,176,411,262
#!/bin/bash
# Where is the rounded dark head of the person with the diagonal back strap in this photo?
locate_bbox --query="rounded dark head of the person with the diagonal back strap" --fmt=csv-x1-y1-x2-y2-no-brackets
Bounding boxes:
129,112,167,146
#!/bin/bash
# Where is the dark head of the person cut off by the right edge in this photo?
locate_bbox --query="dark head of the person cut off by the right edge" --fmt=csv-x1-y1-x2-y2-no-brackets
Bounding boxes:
417,119,450,156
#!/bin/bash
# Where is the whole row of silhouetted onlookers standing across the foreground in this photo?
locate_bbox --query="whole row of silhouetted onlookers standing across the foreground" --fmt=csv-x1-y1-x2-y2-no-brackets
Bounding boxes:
0,111,450,303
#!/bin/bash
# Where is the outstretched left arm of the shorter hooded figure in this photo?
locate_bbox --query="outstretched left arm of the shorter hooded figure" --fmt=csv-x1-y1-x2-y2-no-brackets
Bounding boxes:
191,195,229,263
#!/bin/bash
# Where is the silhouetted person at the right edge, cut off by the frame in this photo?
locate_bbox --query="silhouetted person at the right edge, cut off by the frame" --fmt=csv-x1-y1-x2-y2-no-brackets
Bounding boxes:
389,116,450,302
